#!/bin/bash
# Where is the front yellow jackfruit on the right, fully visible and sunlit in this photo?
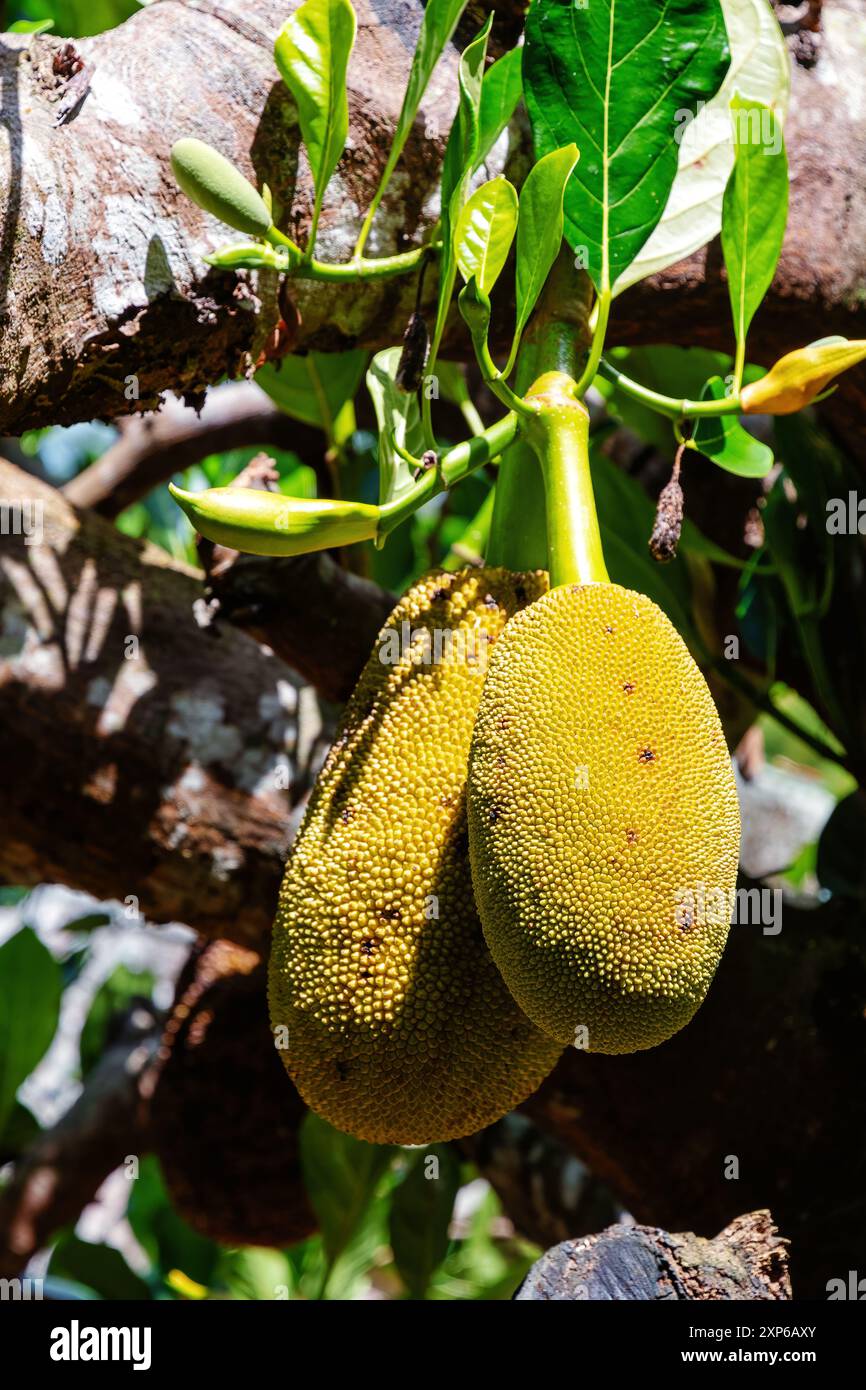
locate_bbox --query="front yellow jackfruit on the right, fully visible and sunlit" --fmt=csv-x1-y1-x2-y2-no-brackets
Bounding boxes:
468,584,740,1052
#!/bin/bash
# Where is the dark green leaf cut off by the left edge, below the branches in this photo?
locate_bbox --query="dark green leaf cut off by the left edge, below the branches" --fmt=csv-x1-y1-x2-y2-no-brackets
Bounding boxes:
0,927,61,1133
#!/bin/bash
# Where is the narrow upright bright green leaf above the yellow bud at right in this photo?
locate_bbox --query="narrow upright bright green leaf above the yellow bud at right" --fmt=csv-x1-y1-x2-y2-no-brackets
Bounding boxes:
721,97,788,359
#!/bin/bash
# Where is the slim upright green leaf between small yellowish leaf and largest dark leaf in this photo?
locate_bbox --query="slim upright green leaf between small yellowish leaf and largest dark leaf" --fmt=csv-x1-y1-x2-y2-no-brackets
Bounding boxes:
503,145,580,377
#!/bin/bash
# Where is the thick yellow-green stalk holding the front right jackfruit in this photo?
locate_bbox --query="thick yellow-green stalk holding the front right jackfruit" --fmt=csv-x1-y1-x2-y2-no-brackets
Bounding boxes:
521,371,610,587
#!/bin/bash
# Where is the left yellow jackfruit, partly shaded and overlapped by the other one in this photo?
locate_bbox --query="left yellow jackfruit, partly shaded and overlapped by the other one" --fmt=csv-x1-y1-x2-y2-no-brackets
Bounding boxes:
270,570,562,1144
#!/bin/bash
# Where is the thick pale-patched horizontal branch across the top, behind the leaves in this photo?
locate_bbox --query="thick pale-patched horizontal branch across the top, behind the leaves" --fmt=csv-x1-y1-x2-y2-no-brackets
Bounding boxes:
0,0,866,456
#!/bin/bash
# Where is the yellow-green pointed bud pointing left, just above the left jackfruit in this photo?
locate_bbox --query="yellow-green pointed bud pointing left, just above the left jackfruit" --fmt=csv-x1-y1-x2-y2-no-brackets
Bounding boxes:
168,484,379,555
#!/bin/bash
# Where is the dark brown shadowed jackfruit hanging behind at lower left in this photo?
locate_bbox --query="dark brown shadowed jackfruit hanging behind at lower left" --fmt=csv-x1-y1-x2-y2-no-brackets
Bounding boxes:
147,941,316,1245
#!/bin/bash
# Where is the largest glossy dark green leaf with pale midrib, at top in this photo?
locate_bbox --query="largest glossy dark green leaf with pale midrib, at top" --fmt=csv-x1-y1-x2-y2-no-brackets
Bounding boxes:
523,0,730,292
